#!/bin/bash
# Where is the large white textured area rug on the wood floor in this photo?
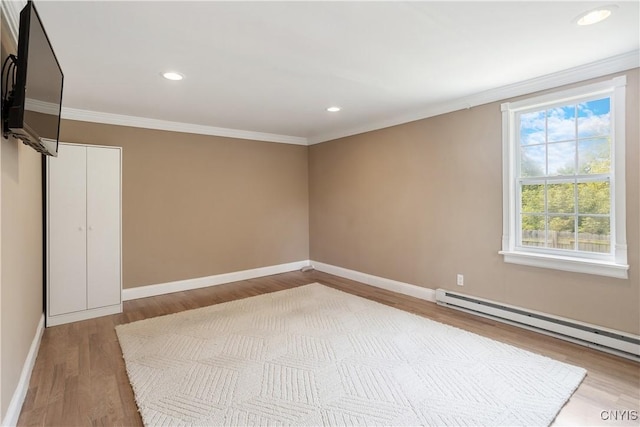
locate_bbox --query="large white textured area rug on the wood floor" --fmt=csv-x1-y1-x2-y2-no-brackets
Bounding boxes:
116,283,586,426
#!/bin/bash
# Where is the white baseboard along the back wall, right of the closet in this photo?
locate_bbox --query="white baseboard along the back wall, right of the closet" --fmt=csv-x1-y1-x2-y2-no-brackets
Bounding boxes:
122,260,309,301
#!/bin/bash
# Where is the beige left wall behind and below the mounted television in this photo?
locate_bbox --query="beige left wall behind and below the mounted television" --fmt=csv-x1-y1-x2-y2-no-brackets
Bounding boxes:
0,23,43,420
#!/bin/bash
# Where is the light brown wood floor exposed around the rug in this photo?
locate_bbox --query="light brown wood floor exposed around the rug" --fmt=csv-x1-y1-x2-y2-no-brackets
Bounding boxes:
18,271,640,426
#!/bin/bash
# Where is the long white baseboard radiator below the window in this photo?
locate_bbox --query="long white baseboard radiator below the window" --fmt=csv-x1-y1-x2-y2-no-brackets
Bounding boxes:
436,289,640,361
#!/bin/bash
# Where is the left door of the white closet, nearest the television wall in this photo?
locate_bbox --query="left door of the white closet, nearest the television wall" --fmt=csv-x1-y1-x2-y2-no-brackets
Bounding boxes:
48,145,87,316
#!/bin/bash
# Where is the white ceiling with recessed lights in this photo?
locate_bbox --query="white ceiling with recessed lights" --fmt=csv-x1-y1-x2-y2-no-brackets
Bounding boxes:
18,0,640,143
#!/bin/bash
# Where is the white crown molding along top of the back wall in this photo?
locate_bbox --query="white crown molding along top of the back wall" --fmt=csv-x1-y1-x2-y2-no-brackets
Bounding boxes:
61,107,308,145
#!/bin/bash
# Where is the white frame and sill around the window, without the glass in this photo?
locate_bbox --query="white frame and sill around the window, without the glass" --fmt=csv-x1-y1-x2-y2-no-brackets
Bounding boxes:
499,76,629,279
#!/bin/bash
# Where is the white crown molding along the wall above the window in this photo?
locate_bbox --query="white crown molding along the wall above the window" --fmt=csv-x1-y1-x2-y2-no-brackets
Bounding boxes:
308,50,640,145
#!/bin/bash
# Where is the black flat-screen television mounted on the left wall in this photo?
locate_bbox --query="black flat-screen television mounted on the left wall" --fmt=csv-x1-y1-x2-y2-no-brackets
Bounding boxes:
3,1,64,156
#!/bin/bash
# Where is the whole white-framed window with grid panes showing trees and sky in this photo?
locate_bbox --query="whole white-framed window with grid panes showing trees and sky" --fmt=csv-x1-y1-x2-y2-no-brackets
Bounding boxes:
500,76,629,279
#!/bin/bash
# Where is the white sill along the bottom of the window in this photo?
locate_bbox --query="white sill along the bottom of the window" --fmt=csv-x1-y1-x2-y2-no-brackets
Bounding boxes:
498,251,629,279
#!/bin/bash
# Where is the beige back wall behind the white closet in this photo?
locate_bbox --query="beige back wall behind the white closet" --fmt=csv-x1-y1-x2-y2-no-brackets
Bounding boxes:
60,120,309,288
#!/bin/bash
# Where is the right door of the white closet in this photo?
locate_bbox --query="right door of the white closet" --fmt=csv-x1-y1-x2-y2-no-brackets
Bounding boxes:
87,147,121,309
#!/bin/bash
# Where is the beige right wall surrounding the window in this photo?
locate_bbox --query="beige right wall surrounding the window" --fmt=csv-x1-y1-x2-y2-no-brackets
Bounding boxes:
309,69,640,334
